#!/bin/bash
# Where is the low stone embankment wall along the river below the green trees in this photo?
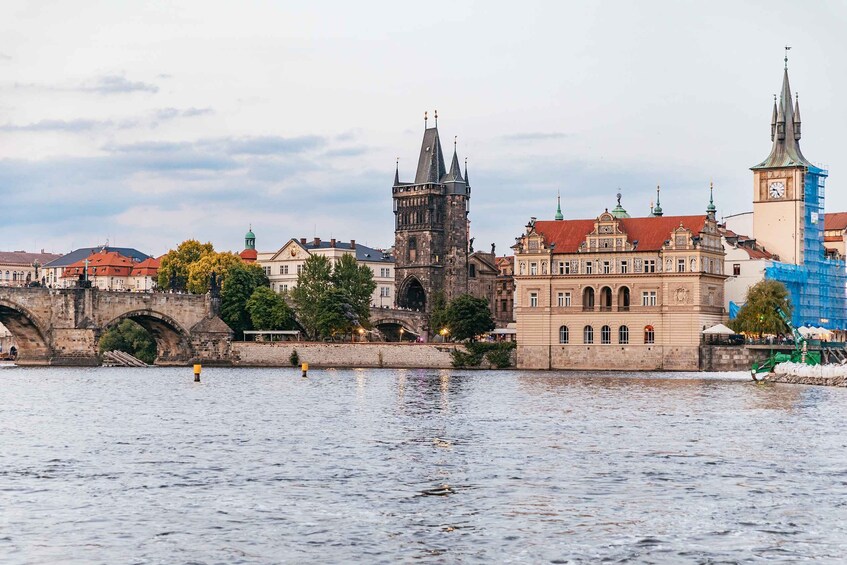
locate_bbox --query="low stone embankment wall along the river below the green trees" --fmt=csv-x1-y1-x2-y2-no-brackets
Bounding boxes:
231,341,460,369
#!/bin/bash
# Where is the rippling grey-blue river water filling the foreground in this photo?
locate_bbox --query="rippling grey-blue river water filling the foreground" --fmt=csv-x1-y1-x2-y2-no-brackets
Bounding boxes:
0,368,847,564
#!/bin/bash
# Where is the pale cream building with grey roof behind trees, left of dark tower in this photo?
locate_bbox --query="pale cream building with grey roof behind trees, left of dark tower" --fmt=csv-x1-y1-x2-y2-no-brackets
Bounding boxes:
256,237,394,308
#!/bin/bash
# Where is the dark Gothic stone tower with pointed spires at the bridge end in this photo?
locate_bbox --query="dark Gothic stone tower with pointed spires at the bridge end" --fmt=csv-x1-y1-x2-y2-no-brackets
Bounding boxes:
392,112,471,311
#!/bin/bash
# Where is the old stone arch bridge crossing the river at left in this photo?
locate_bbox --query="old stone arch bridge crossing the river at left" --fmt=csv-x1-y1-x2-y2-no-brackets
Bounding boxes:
0,287,426,366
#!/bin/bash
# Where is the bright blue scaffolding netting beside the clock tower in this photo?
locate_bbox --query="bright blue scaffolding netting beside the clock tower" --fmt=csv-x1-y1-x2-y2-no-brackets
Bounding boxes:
765,166,847,329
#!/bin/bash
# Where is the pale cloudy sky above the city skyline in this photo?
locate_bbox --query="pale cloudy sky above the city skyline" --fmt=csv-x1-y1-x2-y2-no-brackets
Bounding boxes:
0,0,847,255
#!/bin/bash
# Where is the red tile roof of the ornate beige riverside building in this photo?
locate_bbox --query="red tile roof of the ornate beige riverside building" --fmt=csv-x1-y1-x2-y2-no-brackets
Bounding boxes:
535,216,706,253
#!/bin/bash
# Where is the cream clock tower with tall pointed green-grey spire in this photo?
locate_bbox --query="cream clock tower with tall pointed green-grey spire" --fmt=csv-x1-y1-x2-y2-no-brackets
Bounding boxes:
752,57,826,265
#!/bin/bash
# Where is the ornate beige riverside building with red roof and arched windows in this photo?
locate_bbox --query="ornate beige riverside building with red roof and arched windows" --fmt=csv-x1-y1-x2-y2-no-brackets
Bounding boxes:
513,196,726,370
